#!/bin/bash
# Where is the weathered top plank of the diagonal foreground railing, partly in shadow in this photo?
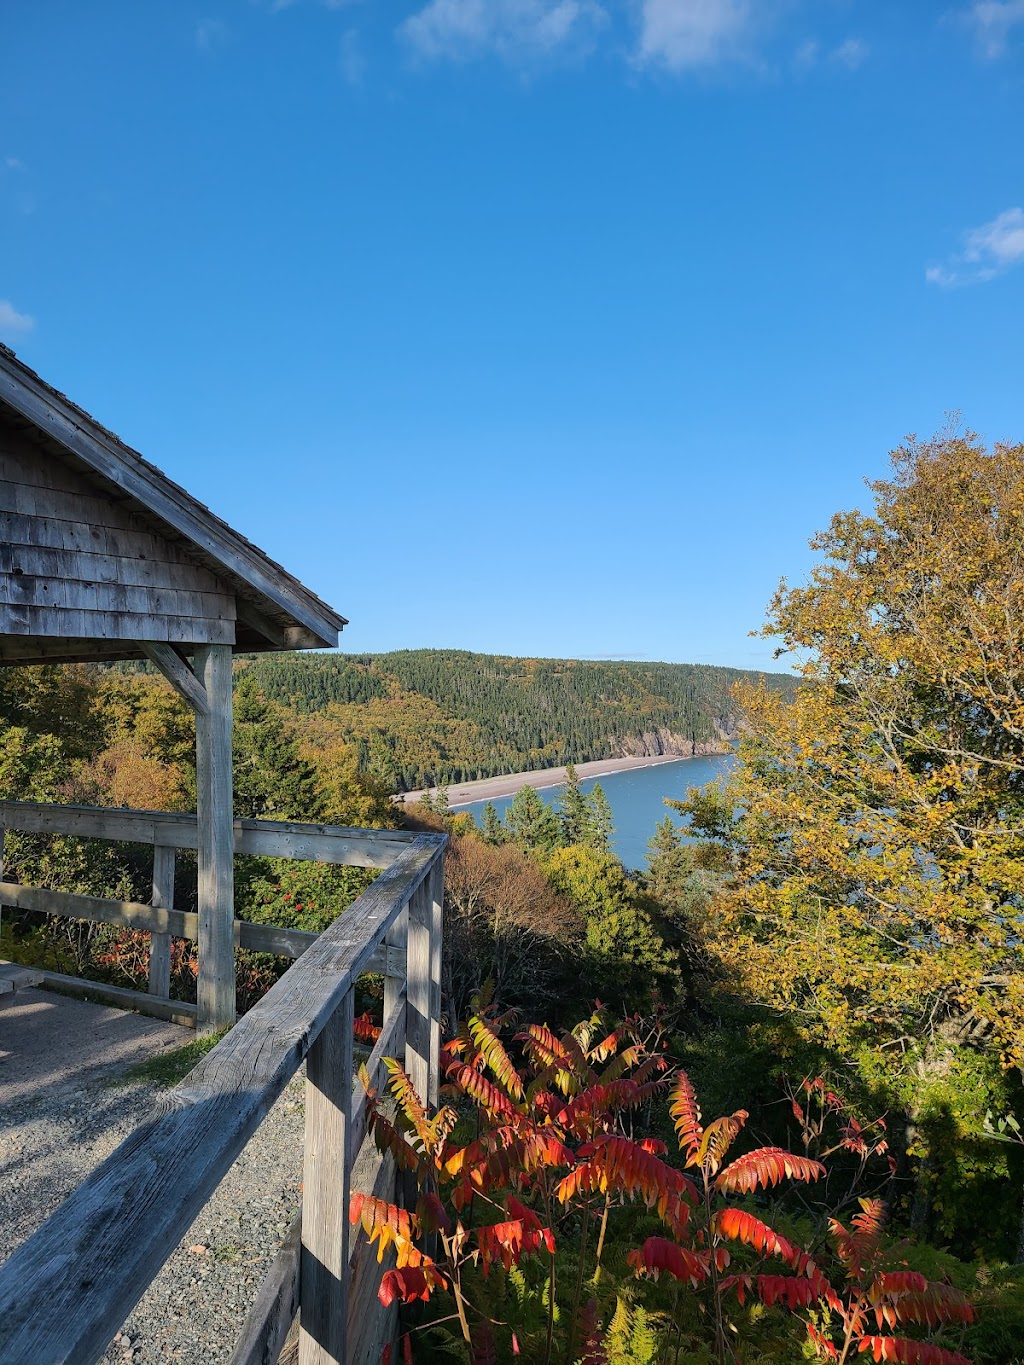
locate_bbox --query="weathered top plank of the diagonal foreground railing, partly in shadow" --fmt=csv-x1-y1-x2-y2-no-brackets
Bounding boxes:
0,835,437,1365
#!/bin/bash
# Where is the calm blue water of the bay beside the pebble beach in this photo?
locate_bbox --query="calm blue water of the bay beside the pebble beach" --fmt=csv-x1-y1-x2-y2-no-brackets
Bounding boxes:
457,753,733,868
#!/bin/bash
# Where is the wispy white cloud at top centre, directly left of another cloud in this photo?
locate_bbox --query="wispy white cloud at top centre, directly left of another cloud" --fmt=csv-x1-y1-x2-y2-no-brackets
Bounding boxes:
399,0,608,61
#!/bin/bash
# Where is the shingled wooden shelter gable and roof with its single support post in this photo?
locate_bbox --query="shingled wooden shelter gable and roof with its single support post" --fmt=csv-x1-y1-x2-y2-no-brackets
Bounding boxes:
0,338,345,1028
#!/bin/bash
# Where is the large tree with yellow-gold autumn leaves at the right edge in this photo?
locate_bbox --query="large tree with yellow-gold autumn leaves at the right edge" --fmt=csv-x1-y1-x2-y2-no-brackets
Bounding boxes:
681,433,1024,1244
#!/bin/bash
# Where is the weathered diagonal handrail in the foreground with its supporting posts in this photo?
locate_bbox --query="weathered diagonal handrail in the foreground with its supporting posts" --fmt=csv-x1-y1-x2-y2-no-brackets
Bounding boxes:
0,829,446,1365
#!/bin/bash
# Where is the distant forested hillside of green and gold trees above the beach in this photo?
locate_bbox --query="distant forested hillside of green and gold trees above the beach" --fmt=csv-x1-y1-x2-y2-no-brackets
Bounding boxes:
240,650,795,790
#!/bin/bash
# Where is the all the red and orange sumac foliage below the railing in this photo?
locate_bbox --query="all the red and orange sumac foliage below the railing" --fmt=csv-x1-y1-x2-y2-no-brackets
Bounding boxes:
351,1010,972,1365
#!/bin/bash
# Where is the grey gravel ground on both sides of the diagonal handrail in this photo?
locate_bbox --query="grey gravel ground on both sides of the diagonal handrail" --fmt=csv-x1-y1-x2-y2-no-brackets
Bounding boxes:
0,991,303,1365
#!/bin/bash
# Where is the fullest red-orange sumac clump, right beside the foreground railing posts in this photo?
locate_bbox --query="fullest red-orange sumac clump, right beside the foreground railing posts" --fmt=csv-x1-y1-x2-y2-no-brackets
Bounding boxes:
350,1011,674,1362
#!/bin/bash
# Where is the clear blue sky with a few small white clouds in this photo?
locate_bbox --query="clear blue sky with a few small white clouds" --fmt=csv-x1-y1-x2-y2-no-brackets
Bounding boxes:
0,0,1024,667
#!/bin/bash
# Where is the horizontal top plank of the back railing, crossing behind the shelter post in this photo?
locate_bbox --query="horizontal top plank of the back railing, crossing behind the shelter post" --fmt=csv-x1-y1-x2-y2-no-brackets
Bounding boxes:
0,801,420,868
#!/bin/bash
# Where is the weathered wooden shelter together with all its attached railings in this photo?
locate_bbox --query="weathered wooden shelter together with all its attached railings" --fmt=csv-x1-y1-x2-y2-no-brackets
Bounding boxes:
0,347,446,1365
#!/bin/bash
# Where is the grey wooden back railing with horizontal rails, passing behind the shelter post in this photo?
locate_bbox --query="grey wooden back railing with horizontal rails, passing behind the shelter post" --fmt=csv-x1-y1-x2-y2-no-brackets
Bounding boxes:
0,801,428,1025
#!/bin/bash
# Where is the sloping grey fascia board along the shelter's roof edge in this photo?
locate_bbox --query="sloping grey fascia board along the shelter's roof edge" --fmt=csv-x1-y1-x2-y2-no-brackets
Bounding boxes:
0,366,345,647
